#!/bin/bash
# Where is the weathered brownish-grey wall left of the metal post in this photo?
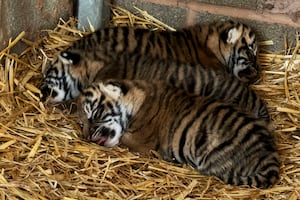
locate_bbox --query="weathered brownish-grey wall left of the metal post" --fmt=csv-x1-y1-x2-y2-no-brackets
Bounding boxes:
0,0,76,51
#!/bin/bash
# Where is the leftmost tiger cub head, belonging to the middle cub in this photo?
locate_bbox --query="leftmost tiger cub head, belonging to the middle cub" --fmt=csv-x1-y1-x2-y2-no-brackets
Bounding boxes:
40,50,109,103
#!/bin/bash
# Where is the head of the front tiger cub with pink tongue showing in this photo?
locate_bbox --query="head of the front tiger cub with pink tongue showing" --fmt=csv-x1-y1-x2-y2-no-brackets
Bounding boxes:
78,80,143,147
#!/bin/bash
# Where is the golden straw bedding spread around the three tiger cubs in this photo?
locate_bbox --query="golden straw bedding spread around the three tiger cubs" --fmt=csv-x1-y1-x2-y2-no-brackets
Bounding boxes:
0,5,300,200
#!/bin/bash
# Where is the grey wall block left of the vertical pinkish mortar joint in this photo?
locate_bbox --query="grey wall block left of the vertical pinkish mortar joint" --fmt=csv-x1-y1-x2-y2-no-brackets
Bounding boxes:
114,0,186,28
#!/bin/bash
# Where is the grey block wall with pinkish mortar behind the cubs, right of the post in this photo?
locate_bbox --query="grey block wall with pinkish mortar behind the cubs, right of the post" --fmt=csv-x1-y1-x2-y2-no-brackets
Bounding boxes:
114,0,300,51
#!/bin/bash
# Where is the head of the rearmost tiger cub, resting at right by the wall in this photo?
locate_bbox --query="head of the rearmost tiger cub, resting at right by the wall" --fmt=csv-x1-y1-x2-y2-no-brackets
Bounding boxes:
218,21,259,82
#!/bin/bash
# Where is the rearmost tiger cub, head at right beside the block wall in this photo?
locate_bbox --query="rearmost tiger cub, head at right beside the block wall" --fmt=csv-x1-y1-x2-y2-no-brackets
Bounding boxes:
71,21,258,82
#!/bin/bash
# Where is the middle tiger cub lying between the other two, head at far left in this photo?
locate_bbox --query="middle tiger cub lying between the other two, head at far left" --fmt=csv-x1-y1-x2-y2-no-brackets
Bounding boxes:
41,51,269,120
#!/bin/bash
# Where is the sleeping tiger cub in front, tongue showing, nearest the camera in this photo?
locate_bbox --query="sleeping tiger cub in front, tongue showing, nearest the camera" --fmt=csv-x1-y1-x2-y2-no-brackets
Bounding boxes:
78,79,280,188
